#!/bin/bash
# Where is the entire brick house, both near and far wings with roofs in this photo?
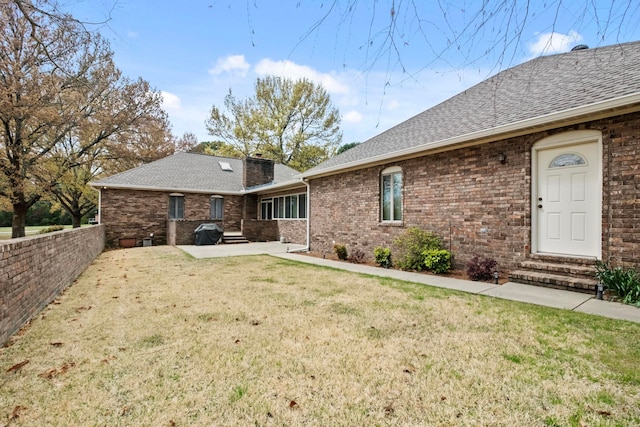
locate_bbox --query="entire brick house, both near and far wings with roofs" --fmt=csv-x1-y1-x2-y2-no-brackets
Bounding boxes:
93,42,640,291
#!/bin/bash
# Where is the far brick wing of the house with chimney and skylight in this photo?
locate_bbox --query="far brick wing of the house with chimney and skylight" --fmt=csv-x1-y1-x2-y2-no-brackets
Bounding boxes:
91,153,307,247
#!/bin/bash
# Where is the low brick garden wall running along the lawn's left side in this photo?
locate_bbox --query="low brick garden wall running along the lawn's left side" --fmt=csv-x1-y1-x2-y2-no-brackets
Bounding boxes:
0,225,105,345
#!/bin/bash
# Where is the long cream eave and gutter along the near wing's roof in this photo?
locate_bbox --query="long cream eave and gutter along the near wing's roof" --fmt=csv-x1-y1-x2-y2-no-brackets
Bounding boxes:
302,92,640,179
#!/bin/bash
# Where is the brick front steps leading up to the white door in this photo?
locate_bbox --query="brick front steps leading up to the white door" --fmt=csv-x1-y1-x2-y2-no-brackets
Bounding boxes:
509,255,598,293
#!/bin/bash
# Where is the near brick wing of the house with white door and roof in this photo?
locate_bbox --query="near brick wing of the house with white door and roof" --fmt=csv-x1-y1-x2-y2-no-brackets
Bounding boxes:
302,42,640,290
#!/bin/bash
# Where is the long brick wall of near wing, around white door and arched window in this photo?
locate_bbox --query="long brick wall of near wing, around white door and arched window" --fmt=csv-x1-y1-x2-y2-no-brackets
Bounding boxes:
310,113,640,270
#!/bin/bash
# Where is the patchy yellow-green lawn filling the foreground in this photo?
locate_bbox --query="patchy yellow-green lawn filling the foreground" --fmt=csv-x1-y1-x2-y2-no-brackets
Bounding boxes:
0,247,640,426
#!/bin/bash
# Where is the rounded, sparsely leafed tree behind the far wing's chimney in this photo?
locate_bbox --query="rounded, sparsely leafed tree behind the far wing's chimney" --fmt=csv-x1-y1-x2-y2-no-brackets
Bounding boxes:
207,76,342,170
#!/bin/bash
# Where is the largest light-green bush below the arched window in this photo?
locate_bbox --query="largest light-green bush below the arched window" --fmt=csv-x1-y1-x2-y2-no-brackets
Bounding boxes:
393,227,442,271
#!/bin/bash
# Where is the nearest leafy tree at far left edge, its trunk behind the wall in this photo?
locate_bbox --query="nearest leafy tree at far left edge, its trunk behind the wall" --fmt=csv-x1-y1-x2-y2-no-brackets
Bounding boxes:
0,2,111,237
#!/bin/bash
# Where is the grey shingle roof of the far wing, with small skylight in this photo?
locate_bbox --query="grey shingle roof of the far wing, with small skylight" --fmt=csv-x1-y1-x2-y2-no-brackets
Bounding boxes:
92,153,300,194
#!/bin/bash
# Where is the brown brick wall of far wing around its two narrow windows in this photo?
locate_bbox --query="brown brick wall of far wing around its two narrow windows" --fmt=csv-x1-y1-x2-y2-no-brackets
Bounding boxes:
100,189,245,247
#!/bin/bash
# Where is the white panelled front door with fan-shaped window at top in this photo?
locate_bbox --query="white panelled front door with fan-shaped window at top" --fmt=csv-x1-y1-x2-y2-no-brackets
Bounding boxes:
532,137,602,258
